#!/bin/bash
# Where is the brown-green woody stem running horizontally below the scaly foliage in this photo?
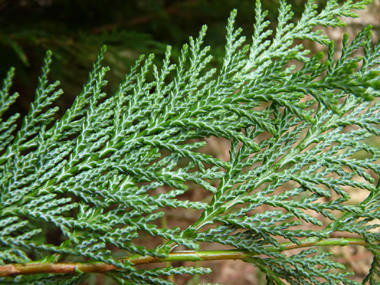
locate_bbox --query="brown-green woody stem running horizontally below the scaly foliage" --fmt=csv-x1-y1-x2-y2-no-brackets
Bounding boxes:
0,238,368,277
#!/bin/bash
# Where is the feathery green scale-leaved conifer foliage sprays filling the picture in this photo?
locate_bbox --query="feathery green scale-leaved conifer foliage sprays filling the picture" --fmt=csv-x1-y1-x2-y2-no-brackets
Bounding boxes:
0,0,380,284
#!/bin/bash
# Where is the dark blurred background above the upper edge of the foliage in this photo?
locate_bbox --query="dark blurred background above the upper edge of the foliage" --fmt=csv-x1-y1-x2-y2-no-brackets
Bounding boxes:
0,0,330,114
